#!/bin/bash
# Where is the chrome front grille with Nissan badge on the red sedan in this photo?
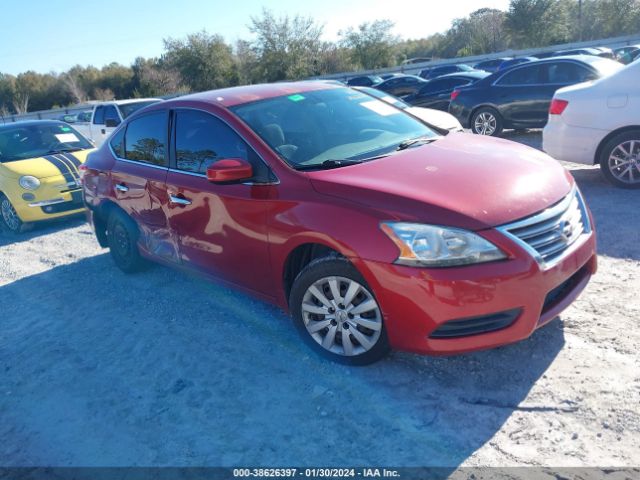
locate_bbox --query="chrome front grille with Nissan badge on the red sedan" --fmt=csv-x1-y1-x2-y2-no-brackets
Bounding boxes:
500,189,591,268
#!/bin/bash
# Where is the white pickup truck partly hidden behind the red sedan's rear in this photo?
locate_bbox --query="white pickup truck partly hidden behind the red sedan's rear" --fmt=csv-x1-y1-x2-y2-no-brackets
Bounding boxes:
73,98,162,147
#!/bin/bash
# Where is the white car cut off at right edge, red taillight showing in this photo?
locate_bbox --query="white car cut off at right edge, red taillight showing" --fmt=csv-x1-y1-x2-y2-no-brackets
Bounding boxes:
542,61,640,188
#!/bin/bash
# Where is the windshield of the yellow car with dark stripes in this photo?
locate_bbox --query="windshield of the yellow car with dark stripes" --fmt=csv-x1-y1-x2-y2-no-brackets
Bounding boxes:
0,122,93,163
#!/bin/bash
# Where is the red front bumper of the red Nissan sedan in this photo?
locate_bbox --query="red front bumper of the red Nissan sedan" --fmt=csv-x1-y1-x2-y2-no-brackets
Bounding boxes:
358,227,597,354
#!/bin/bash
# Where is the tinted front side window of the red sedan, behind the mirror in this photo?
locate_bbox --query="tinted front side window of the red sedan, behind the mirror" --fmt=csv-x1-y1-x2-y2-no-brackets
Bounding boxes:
175,110,270,183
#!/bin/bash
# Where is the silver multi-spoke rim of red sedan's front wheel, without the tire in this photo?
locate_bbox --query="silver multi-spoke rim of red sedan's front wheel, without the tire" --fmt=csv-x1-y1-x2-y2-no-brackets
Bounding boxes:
302,276,382,356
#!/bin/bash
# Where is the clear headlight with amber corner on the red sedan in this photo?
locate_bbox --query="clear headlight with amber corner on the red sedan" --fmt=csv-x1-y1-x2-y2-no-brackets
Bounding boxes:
380,222,507,267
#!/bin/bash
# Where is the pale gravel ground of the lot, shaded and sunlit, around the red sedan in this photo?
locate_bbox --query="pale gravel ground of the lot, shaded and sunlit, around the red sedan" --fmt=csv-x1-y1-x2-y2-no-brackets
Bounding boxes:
0,132,640,467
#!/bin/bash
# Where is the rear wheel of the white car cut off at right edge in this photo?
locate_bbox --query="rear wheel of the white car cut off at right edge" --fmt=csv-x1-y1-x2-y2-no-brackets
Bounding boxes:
599,129,640,189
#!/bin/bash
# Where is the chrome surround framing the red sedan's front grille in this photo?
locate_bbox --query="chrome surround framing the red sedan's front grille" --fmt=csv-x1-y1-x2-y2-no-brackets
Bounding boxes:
496,186,593,270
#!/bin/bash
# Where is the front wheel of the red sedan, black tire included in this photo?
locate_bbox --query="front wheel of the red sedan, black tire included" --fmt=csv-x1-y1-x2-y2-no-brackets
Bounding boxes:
289,256,390,365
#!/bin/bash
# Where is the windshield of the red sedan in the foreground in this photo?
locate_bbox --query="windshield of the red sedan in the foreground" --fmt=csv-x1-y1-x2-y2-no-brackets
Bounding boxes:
231,88,438,168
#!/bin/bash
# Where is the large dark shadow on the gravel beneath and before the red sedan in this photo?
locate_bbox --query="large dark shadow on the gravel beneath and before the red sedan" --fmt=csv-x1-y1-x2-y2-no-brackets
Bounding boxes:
0,254,571,468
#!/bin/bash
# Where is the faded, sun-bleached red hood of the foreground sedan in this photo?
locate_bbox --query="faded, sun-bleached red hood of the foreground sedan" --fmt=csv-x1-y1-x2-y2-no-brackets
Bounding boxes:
308,133,574,230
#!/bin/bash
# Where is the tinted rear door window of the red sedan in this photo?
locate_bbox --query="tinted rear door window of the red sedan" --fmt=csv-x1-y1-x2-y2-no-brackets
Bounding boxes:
124,112,167,166
